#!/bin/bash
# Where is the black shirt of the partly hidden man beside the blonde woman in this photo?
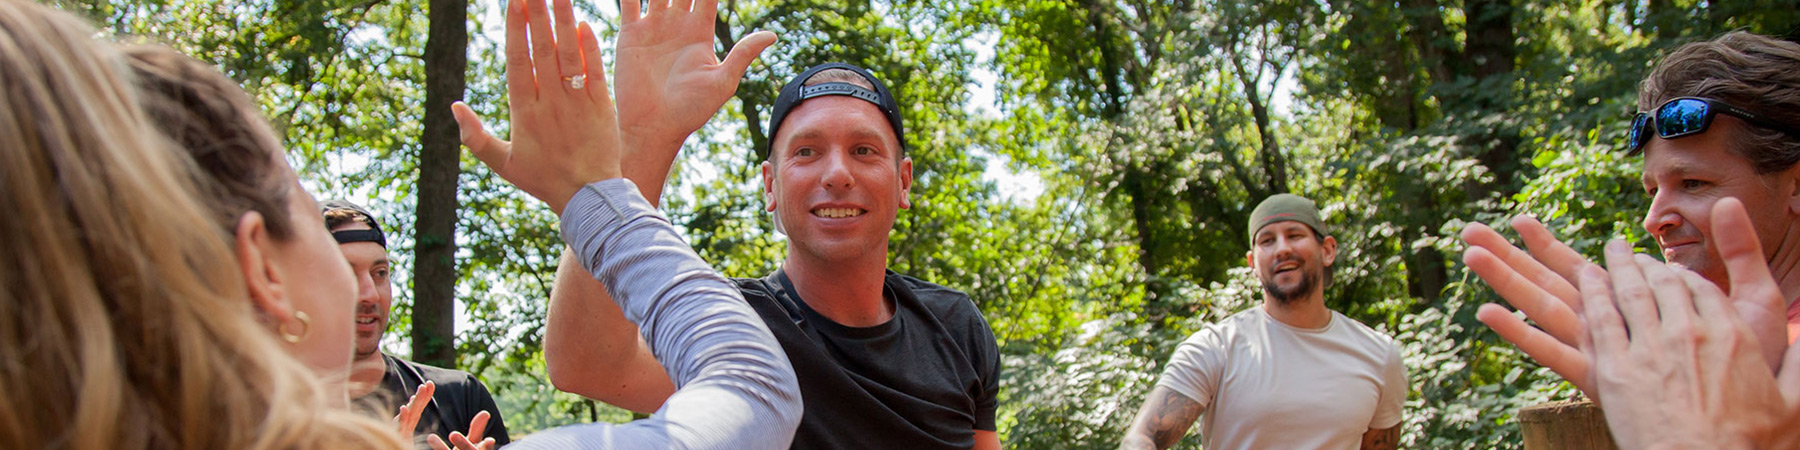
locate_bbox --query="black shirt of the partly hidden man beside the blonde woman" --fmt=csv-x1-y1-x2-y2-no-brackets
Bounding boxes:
355,353,513,448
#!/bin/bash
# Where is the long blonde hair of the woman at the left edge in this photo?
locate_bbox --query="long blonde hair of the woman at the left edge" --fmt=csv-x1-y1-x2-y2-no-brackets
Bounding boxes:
0,0,403,448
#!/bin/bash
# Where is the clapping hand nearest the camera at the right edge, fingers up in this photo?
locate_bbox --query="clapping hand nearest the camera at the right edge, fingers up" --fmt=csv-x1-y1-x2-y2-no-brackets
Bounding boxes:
1580,198,1800,448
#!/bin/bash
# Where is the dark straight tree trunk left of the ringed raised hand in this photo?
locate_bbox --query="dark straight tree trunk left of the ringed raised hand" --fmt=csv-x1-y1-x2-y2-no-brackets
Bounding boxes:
412,0,468,367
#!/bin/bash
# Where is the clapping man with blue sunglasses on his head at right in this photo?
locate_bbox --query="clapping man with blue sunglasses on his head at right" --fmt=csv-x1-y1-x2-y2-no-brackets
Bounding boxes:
1463,32,1800,400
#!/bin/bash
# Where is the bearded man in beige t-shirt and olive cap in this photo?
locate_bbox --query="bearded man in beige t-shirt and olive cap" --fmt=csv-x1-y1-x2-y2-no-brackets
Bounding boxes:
1120,194,1408,450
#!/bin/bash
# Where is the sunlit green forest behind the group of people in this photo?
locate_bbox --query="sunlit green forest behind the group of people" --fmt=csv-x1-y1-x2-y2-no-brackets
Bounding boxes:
49,0,1800,448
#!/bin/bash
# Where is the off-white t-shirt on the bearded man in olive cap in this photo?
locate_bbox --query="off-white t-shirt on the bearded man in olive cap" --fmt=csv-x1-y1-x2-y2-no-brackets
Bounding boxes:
1157,306,1408,450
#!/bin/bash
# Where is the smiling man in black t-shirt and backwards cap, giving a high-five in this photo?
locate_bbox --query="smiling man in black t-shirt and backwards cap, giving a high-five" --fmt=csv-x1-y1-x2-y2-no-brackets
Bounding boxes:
544,2,1001,448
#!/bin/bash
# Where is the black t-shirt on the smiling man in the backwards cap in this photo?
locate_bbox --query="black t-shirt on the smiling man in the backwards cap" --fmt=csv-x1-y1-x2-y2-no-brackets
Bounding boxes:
734,270,1001,448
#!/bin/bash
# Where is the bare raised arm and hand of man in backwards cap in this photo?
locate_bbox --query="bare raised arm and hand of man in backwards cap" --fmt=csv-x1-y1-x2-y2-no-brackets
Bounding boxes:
544,0,776,414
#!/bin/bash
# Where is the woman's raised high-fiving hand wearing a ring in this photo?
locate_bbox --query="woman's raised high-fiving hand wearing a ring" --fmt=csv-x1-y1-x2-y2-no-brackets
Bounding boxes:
452,0,619,214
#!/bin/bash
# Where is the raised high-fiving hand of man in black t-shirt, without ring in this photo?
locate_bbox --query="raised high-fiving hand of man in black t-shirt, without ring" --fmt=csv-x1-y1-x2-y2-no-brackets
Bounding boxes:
612,0,776,202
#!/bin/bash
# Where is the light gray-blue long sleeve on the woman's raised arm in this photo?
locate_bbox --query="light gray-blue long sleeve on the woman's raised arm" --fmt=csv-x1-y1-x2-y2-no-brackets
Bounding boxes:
508,178,801,448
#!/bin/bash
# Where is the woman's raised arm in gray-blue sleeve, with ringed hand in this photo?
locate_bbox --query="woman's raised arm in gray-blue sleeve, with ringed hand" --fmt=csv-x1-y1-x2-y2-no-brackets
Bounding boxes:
455,0,801,448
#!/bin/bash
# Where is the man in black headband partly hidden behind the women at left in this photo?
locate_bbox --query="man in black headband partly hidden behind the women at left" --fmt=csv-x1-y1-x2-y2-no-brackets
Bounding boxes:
320,200,511,448
